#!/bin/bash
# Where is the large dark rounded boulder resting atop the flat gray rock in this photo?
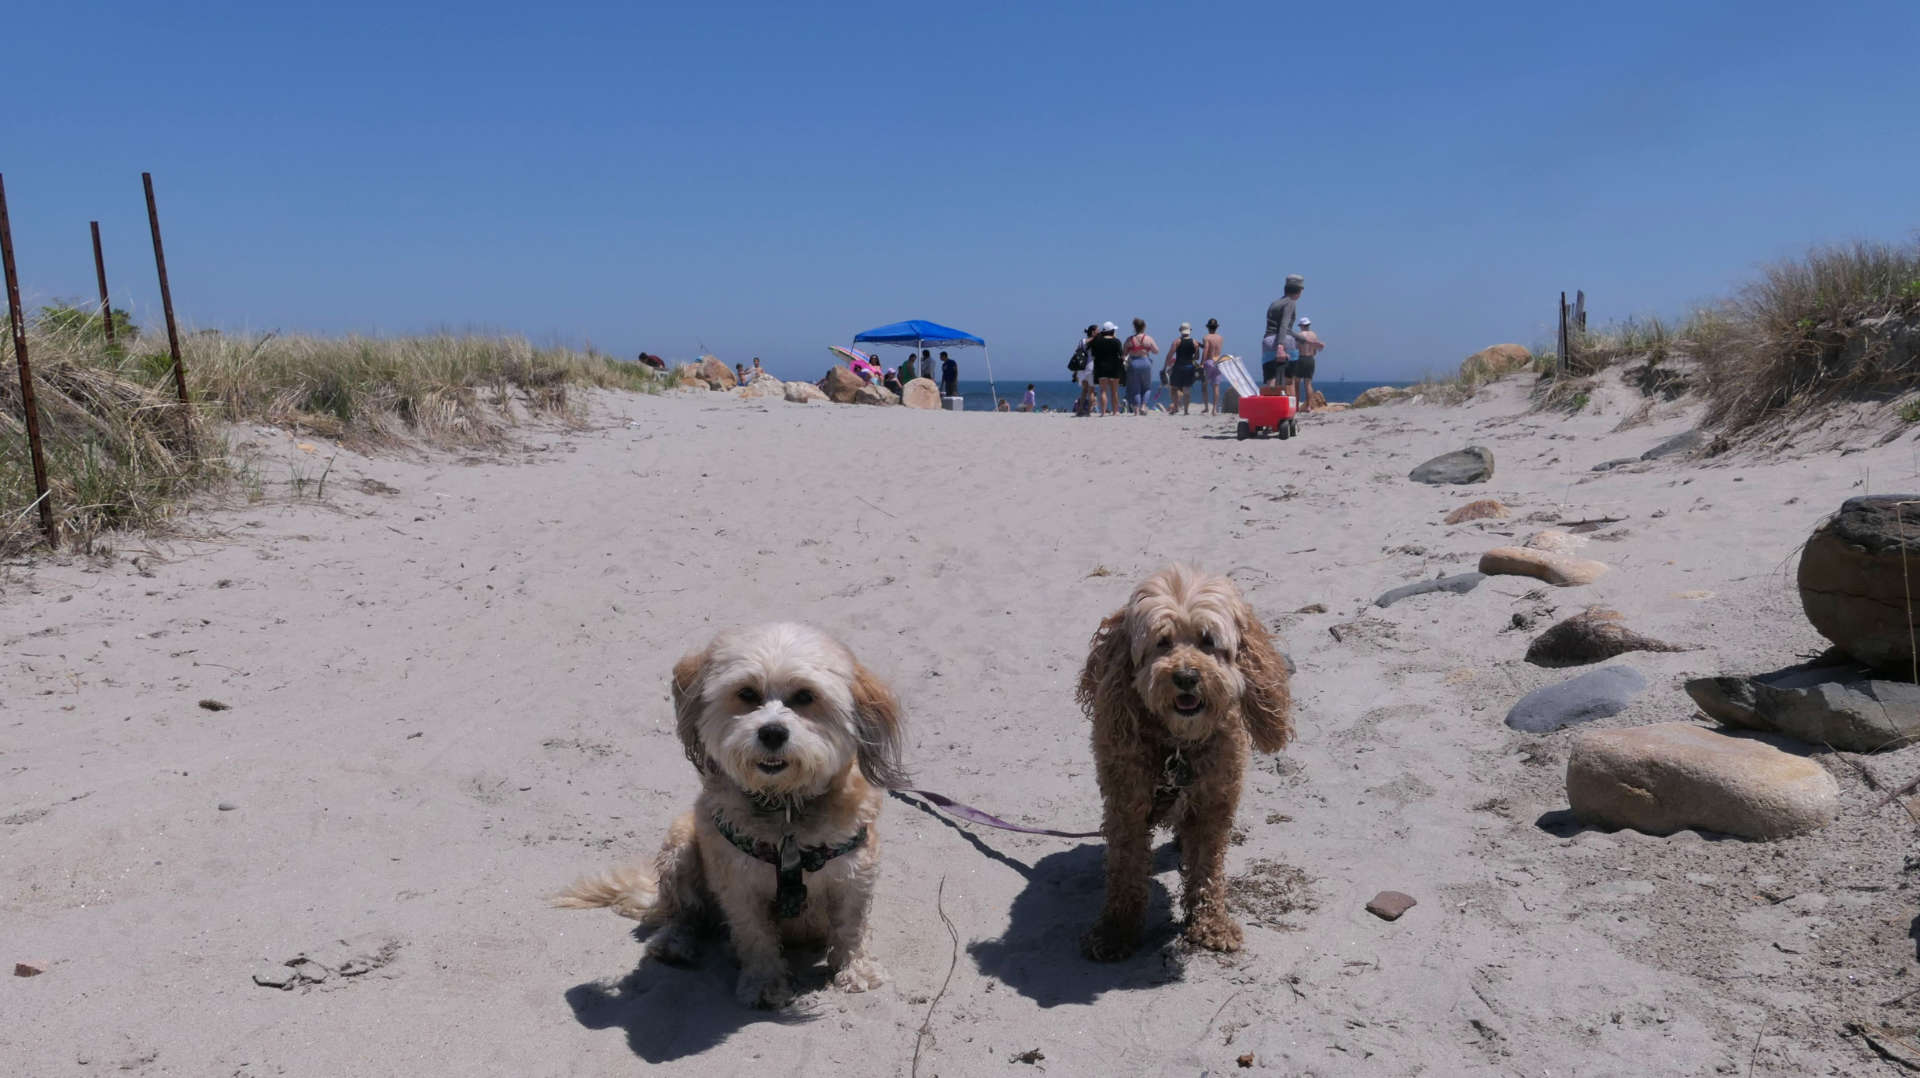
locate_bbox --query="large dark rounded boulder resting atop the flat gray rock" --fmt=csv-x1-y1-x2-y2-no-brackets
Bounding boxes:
1799,494,1920,678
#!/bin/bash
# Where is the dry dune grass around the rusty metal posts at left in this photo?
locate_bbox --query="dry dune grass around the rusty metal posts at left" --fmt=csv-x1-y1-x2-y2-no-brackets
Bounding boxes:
0,319,672,551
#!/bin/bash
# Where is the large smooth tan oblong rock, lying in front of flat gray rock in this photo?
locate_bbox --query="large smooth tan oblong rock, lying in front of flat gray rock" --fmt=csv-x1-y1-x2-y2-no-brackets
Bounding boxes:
1567,723,1839,840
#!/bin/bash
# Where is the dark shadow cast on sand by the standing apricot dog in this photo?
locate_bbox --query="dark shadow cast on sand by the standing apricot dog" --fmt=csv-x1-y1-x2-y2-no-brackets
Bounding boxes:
900,797,1183,1007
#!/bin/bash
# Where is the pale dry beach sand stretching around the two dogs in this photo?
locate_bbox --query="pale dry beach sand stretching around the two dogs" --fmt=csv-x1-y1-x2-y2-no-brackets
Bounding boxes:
0,376,1920,1078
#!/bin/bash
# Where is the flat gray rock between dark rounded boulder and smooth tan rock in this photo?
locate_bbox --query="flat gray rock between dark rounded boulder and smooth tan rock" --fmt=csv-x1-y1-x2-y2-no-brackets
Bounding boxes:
1686,663,1920,753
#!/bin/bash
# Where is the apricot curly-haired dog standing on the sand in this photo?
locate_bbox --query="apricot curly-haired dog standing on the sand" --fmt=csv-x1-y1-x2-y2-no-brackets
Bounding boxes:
1077,565,1292,963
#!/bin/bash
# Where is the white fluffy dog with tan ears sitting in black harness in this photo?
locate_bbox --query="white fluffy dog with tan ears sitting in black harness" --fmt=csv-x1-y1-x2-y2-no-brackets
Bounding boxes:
555,623,904,1007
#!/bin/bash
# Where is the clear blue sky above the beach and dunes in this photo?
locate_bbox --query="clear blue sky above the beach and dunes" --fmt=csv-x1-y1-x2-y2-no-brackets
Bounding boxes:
0,0,1920,380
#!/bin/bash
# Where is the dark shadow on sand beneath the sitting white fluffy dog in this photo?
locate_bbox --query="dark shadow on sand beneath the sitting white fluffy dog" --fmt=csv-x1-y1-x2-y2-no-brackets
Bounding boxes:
566,928,828,1063
